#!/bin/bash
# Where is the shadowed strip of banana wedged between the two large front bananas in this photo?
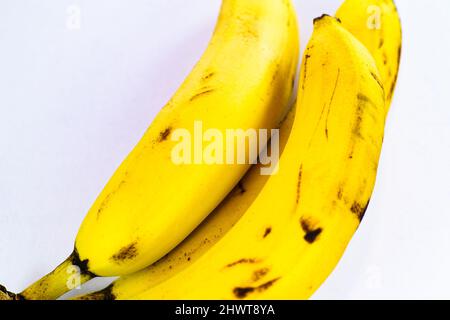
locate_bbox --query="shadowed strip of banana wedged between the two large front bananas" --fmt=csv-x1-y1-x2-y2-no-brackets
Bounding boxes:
74,108,295,300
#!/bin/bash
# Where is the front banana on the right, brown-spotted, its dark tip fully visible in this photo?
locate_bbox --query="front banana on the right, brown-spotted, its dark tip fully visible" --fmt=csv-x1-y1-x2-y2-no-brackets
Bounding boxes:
127,16,387,300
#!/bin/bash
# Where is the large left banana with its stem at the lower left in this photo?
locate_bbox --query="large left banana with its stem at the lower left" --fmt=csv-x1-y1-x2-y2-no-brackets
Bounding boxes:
2,0,299,299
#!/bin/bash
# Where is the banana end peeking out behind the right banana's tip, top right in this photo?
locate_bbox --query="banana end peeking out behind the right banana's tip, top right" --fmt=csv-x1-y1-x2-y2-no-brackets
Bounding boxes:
336,0,402,107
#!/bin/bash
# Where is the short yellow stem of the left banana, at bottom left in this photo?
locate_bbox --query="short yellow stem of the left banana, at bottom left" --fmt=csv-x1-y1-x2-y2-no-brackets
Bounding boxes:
17,250,96,300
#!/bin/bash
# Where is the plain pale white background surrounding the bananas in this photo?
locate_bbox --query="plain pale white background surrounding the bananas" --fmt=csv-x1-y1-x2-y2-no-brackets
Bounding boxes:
0,0,450,299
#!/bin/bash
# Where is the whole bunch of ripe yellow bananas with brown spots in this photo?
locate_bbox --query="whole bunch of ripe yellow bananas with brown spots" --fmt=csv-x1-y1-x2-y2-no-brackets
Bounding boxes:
0,0,401,300
